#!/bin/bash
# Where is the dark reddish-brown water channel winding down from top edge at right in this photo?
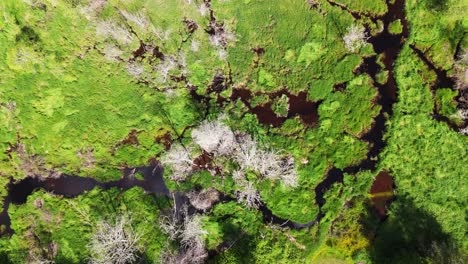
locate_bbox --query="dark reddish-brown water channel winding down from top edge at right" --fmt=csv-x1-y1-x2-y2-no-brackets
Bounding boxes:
315,0,409,219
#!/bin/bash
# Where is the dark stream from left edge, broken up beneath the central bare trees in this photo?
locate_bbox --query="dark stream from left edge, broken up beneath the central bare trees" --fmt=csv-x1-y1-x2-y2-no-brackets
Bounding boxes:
0,163,317,235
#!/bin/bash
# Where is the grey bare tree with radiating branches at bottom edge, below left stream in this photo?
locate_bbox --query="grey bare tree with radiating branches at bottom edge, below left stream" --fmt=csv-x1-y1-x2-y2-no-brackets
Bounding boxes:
89,216,140,264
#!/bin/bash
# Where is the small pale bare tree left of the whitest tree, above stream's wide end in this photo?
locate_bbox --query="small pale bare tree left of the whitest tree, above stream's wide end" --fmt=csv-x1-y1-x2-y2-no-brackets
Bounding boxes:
162,144,193,181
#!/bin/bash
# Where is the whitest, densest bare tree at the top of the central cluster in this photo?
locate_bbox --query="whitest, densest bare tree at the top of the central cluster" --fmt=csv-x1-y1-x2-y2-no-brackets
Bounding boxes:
192,119,235,156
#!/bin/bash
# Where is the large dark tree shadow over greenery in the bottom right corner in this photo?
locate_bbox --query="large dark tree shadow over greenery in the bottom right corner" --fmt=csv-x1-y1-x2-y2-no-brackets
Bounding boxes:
367,196,468,264
